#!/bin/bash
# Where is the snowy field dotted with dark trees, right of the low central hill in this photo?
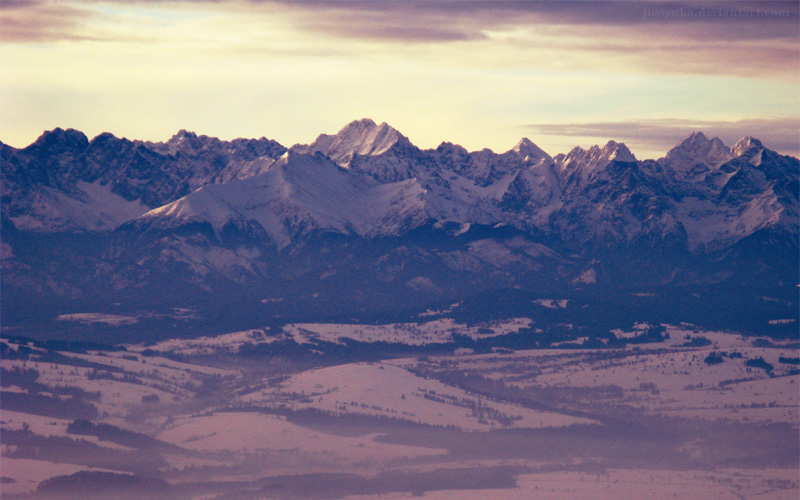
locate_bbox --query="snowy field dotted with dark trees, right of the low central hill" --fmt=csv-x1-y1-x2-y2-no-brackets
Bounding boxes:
400,325,800,425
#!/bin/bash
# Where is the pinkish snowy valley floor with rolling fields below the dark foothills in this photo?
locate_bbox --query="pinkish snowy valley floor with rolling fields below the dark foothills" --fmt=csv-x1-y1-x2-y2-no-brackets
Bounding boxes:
0,318,800,500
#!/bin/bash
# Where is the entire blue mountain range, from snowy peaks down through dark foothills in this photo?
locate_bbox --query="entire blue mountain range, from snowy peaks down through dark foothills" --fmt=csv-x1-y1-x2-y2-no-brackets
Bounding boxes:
0,119,800,340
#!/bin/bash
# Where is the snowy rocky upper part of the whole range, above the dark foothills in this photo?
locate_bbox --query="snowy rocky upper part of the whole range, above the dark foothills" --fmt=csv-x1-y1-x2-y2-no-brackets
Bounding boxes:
7,123,798,251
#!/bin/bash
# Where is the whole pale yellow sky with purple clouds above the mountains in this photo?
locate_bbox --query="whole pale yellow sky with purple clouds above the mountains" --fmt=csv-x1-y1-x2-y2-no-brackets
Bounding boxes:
0,0,800,159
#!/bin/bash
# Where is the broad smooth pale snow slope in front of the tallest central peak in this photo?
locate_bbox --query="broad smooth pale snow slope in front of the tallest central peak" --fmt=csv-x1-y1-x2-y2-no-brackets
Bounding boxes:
137,151,434,246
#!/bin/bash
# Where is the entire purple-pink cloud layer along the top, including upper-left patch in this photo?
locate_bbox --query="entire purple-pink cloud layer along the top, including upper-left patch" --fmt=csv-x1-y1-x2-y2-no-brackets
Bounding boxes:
0,0,800,78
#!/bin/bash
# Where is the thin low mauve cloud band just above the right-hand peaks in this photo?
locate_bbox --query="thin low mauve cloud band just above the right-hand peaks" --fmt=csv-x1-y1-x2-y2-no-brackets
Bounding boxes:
523,117,800,157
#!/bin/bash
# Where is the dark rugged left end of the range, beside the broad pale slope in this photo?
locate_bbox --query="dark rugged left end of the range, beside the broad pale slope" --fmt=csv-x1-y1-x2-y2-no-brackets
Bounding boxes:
0,129,285,232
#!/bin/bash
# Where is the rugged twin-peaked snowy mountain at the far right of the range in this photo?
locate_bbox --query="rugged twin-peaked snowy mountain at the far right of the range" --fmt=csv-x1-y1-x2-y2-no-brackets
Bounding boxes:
651,132,798,251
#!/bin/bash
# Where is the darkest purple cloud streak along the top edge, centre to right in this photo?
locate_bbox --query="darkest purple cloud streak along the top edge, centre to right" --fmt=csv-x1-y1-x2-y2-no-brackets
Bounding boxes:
266,0,800,42
